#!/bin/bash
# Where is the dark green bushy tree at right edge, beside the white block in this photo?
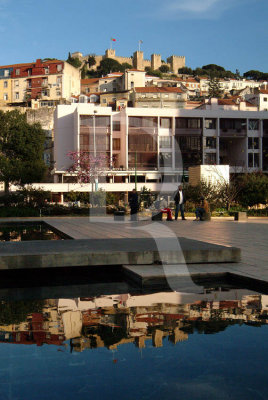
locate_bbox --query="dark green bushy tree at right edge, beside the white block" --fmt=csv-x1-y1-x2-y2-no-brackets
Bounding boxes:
238,172,268,207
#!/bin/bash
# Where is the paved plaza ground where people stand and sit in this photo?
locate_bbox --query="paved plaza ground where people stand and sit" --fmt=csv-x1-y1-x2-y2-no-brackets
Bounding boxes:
0,216,268,282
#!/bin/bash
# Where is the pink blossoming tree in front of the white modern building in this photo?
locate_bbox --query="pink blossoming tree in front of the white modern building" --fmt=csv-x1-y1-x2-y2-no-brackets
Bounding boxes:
67,151,109,191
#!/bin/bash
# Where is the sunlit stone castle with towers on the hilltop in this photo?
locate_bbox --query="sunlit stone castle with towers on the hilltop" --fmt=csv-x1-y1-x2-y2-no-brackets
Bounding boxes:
72,49,185,74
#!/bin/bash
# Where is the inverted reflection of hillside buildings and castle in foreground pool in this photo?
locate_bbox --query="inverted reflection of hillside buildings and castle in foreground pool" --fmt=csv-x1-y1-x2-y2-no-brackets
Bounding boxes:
0,288,268,352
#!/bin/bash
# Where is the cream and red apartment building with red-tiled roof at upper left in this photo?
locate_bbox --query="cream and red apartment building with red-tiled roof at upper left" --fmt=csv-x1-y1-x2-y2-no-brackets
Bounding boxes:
0,59,80,108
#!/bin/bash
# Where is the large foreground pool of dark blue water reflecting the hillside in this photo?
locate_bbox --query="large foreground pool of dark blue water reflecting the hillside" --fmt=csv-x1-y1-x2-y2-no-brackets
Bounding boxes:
0,278,268,400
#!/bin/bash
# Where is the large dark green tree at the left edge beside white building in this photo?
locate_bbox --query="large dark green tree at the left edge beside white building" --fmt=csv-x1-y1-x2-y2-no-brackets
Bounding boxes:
0,110,46,193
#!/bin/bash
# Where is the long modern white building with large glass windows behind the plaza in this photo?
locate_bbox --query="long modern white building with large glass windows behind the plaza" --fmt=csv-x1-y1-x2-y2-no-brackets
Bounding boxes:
50,104,268,198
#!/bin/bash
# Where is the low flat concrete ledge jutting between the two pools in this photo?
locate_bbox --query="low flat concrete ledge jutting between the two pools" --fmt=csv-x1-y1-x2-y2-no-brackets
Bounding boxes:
0,238,241,270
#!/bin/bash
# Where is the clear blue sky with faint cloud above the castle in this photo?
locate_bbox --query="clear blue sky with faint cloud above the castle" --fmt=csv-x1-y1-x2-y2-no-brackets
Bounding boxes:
0,0,268,74
